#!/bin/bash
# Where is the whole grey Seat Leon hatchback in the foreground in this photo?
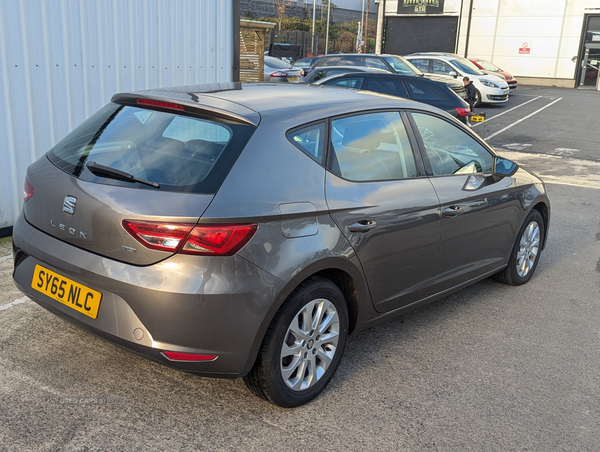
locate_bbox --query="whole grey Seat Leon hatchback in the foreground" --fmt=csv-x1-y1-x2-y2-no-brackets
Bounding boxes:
13,83,550,407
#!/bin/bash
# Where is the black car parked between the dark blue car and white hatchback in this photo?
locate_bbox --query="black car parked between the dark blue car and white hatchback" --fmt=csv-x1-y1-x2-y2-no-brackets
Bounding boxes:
304,53,467,99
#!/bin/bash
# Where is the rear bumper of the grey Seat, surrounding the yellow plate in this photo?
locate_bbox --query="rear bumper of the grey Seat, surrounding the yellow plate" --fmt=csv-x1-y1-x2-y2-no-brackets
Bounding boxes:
13,214,285,378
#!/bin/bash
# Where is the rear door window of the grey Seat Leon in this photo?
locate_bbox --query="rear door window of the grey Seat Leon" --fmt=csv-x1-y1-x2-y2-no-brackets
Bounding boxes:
329,112,418,181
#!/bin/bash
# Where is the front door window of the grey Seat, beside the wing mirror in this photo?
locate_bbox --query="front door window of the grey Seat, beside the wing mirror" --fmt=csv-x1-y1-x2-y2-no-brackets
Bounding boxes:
412,113,493,176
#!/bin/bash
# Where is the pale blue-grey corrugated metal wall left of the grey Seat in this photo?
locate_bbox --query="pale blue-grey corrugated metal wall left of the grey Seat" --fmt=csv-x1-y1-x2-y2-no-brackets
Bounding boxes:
0,0,234,228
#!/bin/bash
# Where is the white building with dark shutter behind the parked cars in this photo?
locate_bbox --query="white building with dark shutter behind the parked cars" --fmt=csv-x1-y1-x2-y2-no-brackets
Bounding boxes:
380,0,600,89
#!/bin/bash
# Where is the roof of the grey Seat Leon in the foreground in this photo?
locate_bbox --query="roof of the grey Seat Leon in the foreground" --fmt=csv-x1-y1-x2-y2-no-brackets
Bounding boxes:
112,82,426,126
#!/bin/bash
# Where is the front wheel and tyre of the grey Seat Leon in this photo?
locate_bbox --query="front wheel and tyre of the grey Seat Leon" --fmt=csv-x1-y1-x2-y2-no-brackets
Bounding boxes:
496,210,545,286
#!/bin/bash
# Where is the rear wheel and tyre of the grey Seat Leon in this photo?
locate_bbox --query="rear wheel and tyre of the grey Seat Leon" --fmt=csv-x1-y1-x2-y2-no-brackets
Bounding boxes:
244,278,348,408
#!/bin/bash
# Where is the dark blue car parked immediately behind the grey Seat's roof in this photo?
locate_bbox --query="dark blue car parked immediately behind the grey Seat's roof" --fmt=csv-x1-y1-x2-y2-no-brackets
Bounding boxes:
315,72,469,123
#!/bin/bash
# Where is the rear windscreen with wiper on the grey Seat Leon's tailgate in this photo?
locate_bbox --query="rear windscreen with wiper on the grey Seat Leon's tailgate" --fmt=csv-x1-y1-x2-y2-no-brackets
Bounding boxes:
48,103,254,193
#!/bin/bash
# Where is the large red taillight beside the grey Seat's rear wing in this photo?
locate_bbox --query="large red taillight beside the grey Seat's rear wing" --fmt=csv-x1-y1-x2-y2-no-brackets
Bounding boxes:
123,220,258,256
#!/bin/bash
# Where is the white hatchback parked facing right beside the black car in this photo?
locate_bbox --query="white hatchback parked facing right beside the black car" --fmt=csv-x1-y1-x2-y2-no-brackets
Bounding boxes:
404,52,508,107
